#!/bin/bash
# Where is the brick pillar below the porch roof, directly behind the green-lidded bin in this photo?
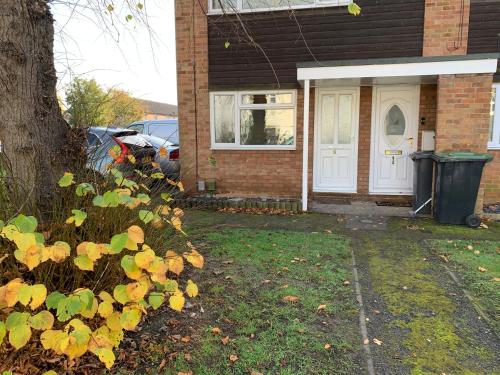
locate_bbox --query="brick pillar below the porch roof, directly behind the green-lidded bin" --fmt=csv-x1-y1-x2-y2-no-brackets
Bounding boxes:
436,74,493,212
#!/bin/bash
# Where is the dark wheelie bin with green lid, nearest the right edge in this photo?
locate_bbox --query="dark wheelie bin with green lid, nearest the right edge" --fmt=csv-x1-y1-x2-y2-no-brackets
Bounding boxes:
432,152,493,228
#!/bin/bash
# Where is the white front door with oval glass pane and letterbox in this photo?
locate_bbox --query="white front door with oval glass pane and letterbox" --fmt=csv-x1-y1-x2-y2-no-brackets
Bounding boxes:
370,85,420,195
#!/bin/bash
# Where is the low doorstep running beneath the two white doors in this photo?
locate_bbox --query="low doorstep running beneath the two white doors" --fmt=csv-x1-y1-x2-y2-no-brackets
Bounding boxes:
309,201,411,217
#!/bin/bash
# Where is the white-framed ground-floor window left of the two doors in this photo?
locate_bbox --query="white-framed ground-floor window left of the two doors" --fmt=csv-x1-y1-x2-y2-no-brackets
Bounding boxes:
210,91,296,150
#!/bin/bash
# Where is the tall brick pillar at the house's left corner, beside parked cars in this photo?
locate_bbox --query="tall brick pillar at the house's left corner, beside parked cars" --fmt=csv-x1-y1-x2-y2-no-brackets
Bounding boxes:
175,0,210,193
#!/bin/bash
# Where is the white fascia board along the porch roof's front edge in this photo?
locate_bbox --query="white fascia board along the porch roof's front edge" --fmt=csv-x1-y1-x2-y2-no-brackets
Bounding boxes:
297,59,497,81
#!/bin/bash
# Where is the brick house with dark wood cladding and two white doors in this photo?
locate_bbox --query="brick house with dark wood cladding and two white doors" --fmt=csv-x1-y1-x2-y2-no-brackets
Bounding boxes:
176,0,500,209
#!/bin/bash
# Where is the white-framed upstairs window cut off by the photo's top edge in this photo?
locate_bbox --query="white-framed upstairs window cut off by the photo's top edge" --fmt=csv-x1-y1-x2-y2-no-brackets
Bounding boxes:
209,0,352,13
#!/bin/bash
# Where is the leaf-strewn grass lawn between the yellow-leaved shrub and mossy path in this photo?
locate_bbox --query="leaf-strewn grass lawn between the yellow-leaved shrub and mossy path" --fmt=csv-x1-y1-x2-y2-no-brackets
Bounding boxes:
115,219,363,375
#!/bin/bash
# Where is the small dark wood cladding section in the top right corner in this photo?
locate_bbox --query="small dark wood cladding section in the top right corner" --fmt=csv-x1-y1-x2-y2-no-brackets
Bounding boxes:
467,0,500,81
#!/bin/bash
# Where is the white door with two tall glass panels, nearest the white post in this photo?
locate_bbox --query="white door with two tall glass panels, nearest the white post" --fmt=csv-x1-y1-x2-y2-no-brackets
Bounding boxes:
313,88,359,193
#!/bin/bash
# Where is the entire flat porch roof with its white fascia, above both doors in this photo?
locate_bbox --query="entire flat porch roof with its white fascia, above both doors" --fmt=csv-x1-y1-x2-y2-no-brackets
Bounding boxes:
297,53,500,81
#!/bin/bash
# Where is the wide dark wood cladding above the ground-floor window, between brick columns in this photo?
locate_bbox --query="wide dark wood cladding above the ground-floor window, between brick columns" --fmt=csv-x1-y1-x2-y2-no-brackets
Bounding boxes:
208,0,425,89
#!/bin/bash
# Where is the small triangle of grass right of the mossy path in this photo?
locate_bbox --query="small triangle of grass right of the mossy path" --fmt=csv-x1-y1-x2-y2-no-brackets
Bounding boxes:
431,240,500,334
